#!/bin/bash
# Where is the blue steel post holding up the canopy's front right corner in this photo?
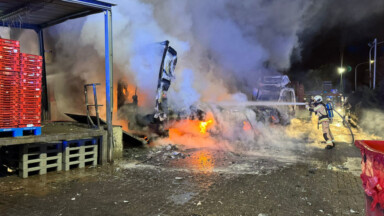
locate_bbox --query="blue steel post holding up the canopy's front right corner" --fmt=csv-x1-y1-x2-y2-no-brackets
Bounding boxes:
104,10,114,162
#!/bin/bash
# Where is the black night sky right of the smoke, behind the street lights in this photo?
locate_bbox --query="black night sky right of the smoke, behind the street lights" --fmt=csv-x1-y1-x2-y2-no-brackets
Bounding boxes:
288,1,384,92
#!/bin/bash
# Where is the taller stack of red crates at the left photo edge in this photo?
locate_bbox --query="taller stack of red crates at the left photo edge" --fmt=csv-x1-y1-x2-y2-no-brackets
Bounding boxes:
0,39,21,128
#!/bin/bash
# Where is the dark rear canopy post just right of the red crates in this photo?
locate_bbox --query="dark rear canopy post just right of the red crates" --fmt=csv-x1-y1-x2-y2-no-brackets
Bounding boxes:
37,29,49,121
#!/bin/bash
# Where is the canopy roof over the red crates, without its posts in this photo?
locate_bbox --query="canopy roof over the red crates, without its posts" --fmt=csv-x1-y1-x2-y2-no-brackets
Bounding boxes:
0,0,113,29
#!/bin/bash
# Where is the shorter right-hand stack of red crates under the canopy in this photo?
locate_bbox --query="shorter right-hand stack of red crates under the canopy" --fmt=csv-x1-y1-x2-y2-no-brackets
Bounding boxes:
19,53,43,127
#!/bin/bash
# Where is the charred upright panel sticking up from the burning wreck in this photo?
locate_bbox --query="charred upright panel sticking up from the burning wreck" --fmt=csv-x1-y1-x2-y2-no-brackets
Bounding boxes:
154,47,177,121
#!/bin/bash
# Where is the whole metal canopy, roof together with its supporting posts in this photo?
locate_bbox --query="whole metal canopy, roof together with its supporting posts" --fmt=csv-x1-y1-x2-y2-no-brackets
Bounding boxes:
0,0,115,161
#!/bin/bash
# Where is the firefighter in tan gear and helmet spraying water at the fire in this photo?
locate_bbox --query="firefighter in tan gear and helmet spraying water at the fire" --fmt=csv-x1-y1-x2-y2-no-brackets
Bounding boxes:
305,95,335,149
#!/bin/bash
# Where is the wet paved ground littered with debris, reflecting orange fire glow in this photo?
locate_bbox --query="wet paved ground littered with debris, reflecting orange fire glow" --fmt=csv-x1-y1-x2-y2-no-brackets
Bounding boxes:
0,114,378,216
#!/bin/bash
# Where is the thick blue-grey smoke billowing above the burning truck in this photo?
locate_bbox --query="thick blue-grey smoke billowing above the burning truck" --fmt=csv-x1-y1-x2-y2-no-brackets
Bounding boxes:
57,0,307,113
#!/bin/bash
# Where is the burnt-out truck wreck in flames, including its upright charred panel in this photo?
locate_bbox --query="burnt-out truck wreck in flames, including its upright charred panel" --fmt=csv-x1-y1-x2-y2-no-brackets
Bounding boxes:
117,41,296,141
